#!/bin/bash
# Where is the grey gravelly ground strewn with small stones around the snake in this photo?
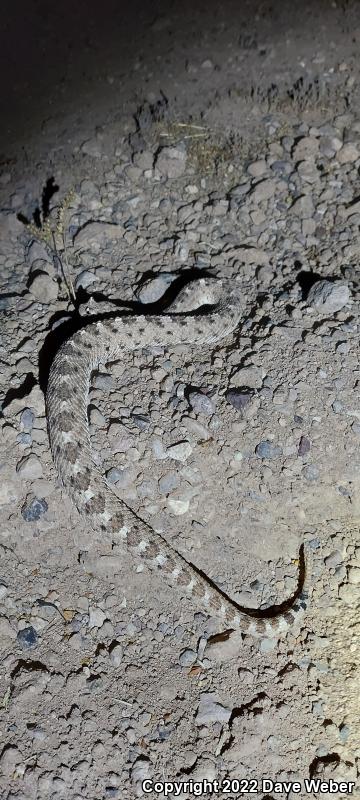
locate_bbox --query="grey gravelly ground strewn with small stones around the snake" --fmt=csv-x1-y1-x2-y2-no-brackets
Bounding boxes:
0,3,360,800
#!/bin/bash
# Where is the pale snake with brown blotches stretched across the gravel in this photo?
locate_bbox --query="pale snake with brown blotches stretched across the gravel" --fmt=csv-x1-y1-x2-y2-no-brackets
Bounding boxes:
46,278,311,636
